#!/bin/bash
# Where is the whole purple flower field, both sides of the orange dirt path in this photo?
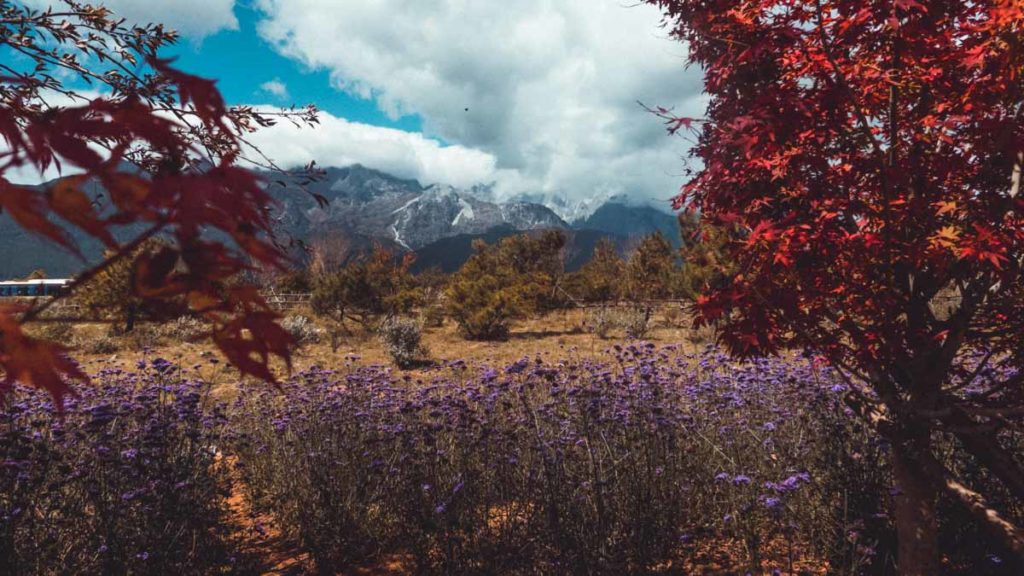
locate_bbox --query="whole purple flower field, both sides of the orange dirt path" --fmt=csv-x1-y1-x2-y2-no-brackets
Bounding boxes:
0,343,1015,574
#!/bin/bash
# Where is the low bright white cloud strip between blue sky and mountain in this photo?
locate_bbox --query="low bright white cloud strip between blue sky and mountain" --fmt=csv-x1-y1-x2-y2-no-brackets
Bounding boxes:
248,107,503,187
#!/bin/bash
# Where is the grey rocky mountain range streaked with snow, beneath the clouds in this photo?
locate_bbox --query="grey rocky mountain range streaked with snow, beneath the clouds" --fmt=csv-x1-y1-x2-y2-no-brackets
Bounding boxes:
0,165,679,278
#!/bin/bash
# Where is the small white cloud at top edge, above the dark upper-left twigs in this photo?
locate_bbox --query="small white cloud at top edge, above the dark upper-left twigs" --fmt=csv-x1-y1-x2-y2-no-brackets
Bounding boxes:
23,0,239,40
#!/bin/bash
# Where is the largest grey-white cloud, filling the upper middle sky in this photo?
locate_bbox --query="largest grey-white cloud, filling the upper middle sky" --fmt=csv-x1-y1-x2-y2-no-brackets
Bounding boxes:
257,0,705,203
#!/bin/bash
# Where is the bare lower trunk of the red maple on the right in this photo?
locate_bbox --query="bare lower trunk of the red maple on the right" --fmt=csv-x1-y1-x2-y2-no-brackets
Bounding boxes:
892,433,941,576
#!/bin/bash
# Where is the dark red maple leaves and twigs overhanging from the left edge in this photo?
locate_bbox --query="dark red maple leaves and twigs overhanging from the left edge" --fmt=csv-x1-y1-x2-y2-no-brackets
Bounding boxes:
0,0,316,403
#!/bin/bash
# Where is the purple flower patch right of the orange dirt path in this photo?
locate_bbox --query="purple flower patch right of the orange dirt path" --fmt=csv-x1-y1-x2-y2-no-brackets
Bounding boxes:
231,344,887,573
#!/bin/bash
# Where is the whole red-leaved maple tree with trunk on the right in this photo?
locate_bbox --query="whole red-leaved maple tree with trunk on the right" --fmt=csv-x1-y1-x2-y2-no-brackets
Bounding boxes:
648,0,1024,574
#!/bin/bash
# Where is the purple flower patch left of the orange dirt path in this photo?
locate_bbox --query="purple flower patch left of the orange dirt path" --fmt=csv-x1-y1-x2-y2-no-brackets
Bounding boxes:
0,365,229,574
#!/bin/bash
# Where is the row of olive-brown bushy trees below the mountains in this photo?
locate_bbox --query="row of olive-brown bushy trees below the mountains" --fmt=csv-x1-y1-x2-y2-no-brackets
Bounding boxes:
262,214,731,339
